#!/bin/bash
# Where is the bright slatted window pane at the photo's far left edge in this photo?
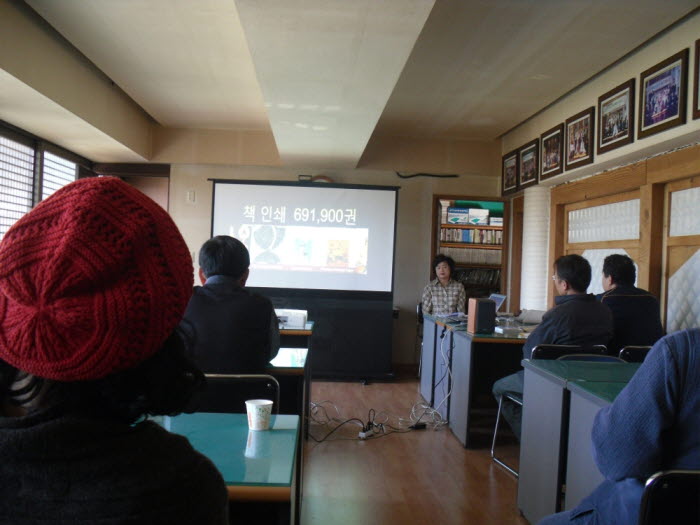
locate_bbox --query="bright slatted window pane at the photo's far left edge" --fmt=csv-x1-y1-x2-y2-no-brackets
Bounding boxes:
0,135,34,240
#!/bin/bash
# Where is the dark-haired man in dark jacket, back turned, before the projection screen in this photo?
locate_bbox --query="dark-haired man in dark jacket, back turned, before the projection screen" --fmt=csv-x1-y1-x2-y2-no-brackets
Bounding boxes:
185,235,279,374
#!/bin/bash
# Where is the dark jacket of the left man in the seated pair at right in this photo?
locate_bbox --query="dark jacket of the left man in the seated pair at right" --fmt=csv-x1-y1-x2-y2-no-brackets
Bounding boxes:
523,294,613,359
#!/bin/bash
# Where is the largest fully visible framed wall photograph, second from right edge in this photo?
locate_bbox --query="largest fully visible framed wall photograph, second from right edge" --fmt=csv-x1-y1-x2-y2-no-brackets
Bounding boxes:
637,49,688,139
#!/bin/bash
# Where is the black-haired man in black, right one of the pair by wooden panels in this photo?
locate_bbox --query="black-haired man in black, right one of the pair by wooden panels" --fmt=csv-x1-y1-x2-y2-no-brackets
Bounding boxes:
598,254,664,355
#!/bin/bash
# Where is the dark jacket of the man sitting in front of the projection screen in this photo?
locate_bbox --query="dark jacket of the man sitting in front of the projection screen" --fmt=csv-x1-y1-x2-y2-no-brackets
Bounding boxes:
184,275,279,374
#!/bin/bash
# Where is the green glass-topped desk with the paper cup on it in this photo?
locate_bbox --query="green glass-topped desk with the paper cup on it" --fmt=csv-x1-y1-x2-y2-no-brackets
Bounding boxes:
162,412,300,523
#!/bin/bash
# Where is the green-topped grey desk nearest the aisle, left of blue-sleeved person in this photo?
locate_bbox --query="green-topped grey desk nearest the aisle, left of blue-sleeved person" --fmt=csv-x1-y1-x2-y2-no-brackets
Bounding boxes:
518,359,639,523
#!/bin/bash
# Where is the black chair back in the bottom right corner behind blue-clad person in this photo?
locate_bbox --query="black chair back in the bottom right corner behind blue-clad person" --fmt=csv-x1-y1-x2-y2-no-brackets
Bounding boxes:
639,470,700,525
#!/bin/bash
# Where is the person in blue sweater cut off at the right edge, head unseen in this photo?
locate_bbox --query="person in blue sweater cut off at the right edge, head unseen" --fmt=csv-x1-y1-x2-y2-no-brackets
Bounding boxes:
540,328,700,525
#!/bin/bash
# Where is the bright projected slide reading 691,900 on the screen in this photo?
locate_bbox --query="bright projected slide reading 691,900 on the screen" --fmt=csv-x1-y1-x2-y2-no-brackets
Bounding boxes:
213,182,396,291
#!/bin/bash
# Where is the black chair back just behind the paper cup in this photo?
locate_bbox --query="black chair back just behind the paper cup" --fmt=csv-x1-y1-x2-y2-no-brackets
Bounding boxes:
187,374,280,414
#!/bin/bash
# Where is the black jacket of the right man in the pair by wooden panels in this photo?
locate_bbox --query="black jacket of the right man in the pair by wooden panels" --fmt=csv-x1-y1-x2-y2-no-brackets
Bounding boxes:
598,286,664,354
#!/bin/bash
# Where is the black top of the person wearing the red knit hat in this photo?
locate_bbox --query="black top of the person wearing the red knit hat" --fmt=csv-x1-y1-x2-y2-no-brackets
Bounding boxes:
0,407,228,525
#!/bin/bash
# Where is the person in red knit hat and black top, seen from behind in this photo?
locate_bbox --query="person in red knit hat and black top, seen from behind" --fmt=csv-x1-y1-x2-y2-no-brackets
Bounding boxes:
0,177,227,525
